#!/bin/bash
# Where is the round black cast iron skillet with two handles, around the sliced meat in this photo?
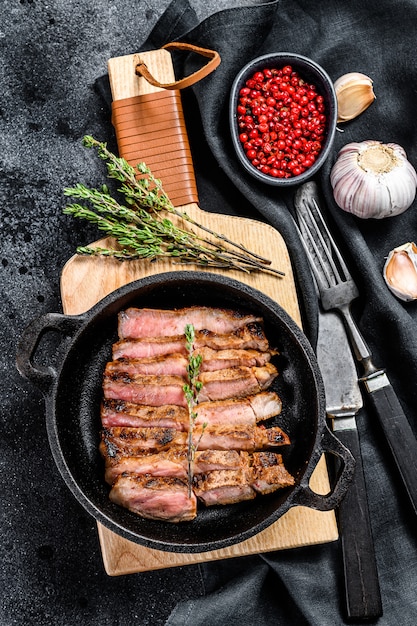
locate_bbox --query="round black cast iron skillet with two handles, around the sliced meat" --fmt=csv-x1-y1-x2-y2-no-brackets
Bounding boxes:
17,271,354,552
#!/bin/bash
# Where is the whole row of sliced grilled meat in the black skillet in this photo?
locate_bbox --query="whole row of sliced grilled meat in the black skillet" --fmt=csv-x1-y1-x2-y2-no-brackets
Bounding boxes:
99,307,294,522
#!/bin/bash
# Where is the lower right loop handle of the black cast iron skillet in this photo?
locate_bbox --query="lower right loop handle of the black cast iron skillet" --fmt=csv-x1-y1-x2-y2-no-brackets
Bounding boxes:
296,425,356,511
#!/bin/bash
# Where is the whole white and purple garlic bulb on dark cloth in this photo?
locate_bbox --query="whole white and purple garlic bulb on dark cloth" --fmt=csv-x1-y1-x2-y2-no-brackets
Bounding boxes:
330,140,417,219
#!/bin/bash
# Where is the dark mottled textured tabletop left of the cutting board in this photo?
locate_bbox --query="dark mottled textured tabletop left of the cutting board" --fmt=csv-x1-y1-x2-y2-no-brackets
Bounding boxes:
0,0,240,626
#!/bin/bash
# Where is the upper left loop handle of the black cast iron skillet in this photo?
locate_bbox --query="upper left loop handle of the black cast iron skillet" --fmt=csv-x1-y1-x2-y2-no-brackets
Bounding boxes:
16,313,84,394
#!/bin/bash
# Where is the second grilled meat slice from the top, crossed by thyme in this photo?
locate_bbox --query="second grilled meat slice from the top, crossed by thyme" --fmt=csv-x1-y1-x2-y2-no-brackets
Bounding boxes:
113,322,269,360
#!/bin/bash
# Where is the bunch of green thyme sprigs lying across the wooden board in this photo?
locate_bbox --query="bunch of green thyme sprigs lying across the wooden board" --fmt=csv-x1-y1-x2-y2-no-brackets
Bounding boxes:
64,136,284,276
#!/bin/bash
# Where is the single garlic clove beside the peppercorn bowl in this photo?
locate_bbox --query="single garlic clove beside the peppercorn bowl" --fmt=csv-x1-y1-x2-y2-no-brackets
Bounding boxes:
334,72,375,122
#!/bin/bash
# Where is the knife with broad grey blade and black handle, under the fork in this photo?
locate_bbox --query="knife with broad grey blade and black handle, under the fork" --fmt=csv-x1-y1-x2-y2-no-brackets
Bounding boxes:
317,311,382,620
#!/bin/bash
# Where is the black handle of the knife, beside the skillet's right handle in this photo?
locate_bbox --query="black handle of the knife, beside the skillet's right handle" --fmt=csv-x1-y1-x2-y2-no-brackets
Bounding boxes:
335,428,382,621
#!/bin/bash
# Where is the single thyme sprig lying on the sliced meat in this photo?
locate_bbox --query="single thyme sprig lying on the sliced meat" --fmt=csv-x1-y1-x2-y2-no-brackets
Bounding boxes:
183,324,207,496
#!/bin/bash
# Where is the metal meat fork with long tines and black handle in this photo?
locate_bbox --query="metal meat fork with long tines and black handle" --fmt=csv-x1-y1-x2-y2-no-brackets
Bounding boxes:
296,182,417,514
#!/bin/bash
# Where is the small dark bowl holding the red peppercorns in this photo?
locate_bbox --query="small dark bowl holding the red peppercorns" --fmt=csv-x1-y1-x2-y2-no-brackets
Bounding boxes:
229,52,337,187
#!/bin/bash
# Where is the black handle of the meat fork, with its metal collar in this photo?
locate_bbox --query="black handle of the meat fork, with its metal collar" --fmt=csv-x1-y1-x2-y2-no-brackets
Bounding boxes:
362,370,417,514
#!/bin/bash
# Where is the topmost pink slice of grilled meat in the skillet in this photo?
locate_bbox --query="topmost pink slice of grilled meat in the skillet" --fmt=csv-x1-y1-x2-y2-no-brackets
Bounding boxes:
118,306,261,339
